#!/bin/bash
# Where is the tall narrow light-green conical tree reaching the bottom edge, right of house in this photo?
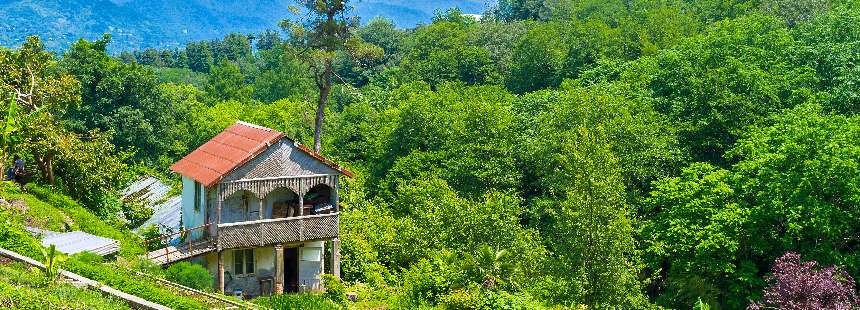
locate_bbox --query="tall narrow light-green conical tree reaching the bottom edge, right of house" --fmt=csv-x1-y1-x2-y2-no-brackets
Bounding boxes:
532,125,647,308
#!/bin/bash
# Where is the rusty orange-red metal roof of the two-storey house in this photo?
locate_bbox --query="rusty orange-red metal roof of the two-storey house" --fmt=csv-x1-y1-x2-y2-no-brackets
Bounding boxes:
170,121,352,187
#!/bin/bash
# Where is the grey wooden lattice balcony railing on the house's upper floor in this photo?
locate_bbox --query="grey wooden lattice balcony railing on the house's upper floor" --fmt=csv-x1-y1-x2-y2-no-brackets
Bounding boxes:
217,213,340,250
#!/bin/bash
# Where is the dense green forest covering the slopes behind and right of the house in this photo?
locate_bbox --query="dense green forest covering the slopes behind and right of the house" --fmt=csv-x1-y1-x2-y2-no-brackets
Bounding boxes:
0,0,860,309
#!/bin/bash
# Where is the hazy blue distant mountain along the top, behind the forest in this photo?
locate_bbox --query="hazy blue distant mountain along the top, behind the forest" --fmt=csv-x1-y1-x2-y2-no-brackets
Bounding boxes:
0,0,494,51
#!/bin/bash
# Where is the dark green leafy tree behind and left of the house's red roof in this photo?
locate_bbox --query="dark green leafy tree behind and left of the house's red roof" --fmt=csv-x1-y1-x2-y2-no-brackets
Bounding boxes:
61,36,196,164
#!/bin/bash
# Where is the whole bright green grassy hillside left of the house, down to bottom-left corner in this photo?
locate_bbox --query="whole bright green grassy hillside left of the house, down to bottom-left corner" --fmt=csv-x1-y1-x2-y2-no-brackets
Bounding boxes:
0,182,223,309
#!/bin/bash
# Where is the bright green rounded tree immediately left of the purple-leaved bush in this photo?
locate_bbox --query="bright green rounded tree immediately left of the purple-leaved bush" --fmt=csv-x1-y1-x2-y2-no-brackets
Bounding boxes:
639,163,755,307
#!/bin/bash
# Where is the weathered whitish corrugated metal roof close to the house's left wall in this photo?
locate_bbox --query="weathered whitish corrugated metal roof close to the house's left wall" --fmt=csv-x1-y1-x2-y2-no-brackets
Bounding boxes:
122,177,182,233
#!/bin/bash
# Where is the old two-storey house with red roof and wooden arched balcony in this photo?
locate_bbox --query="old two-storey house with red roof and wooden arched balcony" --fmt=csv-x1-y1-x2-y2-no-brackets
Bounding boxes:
160,122,352,296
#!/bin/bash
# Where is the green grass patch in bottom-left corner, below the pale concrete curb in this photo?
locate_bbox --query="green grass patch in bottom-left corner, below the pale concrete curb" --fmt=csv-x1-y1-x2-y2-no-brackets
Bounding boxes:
0,263,130,309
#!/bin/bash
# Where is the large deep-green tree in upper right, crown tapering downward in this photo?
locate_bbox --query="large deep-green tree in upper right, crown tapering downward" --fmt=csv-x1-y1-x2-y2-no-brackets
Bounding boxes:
623,16,818,165
